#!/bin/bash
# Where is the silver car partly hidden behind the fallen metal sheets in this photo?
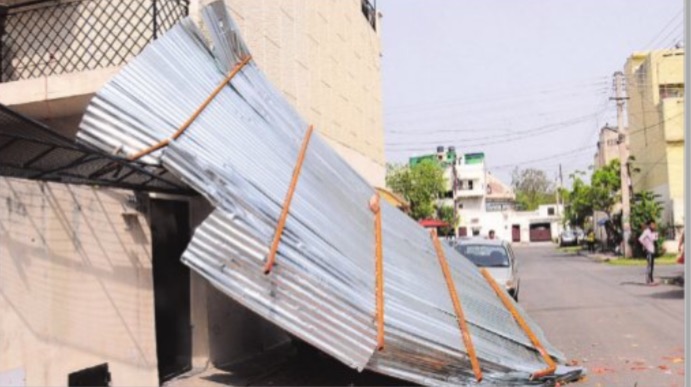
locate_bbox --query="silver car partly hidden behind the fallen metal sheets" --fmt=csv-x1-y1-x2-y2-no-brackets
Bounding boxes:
454,238,520,301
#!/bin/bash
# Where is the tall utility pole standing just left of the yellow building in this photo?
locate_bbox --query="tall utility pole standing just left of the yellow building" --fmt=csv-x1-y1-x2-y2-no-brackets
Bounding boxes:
610,71,631,257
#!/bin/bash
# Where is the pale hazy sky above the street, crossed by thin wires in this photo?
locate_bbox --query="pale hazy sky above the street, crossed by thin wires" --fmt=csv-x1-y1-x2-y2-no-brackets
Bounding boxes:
377,0,684,186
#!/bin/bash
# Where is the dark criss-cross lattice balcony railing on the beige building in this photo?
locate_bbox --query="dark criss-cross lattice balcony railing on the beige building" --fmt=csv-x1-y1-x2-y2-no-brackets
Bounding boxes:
0,0,189,82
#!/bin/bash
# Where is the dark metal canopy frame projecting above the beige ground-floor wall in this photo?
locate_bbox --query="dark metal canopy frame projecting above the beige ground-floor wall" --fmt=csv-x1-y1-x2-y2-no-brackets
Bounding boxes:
0,104,196,195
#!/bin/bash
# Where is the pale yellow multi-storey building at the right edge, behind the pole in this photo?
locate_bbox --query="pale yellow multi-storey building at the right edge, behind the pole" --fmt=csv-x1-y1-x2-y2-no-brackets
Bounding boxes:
624,48,685,237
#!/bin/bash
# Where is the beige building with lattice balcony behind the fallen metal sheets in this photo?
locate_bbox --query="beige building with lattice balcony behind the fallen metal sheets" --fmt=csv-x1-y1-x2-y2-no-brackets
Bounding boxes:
0,0,385,386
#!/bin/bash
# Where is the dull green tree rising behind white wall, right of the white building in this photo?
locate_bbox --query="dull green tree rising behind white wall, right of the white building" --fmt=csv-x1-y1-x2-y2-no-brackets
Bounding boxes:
511,167,555,211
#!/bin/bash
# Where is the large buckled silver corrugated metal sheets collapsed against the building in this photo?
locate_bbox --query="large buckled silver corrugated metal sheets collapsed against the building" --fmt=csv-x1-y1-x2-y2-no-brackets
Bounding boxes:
78,2,581,385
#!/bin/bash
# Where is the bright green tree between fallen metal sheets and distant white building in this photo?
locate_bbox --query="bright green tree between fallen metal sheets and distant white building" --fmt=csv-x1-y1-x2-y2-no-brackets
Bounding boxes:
386,160,446,220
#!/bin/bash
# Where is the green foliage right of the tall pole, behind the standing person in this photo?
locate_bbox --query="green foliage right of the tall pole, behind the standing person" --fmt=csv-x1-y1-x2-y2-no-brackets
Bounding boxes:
629,191,664,257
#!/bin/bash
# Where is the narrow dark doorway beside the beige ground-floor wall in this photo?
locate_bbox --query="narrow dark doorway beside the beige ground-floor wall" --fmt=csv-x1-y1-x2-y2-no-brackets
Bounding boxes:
150,200,192,383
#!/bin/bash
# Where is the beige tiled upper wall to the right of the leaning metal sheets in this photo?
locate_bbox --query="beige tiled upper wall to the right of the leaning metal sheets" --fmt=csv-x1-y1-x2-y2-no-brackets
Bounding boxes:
218,0,385,187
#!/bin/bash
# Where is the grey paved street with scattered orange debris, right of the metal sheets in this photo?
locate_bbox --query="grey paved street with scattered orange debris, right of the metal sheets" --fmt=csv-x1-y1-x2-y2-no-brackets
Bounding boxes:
515,246,684,387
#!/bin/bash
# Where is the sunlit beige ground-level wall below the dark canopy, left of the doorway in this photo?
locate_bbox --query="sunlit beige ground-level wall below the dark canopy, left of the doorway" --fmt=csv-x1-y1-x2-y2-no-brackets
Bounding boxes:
0,178,158,386
